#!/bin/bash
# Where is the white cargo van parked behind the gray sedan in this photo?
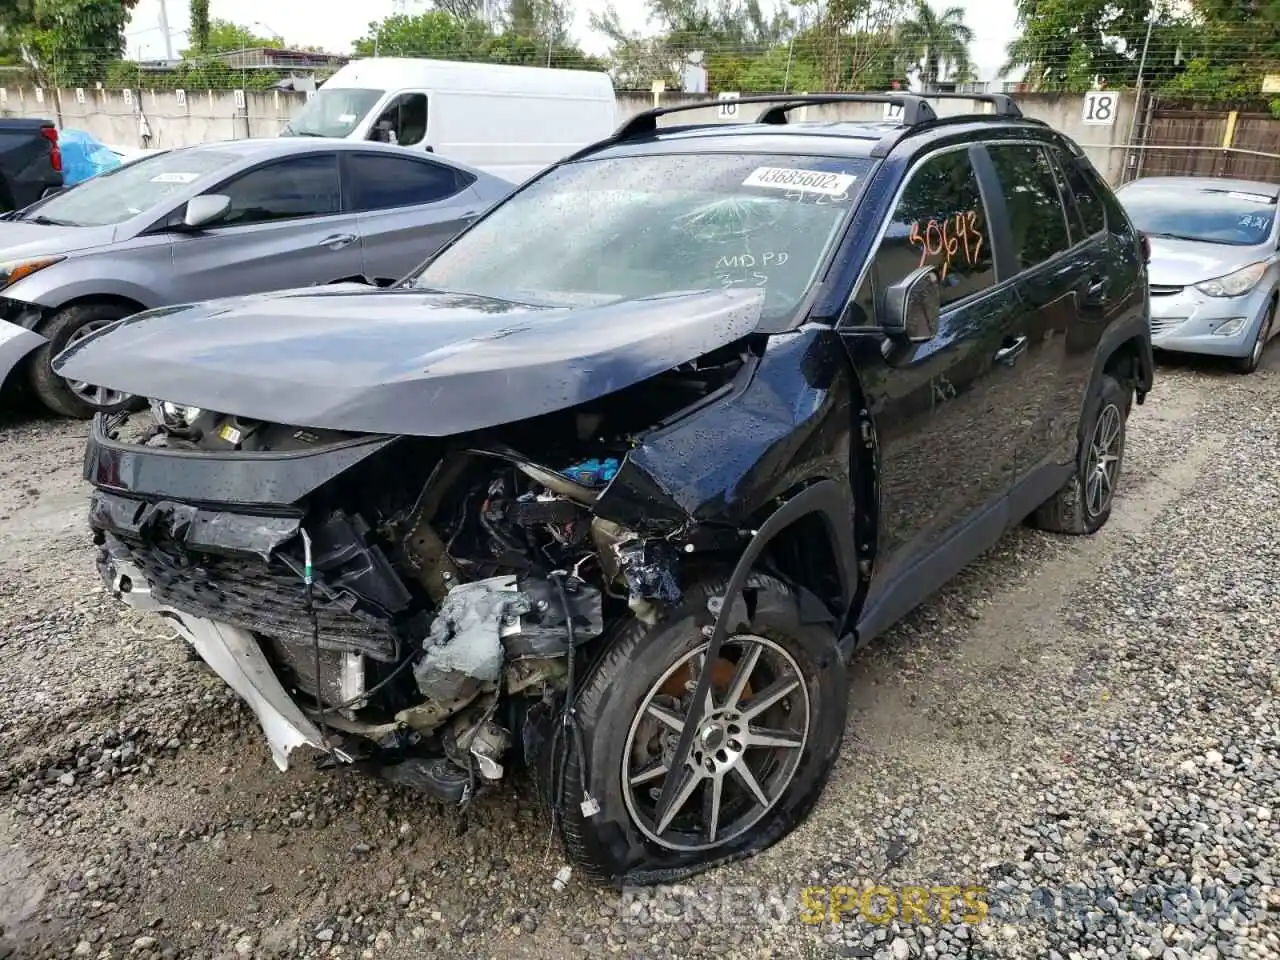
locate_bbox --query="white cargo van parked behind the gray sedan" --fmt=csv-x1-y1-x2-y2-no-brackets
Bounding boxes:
283,56,617,183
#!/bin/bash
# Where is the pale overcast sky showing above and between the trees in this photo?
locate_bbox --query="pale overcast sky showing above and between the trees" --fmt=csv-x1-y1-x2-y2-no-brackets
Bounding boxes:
128,0,1014,79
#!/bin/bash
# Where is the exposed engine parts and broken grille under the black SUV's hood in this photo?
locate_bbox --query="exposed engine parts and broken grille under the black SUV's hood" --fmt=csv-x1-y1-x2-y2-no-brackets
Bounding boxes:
91,340,753,803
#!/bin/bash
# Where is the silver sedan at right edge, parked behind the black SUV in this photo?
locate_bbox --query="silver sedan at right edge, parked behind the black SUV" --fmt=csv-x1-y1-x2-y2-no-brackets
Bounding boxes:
1116,177,1280,374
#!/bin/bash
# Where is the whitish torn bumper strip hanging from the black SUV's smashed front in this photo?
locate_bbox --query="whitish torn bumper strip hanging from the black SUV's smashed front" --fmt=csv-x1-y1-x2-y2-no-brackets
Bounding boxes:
104,558,332,771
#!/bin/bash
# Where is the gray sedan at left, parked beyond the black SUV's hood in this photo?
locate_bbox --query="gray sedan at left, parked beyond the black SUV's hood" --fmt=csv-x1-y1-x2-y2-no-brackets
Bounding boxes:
0,138,513,417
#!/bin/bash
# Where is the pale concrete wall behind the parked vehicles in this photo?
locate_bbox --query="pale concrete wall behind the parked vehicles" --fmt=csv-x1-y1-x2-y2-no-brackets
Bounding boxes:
0,87,1133,183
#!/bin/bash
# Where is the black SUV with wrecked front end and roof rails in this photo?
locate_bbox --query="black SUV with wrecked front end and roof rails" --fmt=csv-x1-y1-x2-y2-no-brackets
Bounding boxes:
56,93,1152,883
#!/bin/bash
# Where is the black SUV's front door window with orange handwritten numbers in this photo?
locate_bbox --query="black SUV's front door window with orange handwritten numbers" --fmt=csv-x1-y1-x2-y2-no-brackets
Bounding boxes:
874,150,996,306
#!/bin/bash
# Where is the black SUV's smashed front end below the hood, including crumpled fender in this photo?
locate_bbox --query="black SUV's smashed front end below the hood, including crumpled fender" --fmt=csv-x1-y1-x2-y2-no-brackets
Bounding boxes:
80,321,847,809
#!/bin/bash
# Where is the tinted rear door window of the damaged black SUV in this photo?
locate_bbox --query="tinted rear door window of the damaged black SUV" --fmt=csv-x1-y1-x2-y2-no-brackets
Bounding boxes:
987,143,1071,270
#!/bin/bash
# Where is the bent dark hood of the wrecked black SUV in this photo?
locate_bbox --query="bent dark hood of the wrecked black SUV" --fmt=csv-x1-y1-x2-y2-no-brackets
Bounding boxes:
54,284,764,436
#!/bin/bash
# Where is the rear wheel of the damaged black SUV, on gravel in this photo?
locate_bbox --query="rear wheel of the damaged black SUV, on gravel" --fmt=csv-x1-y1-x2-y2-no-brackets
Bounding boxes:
1030,374,1133,536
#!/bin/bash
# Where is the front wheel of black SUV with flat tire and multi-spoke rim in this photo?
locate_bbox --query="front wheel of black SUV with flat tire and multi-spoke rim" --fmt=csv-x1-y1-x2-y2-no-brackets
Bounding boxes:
539,576,849,886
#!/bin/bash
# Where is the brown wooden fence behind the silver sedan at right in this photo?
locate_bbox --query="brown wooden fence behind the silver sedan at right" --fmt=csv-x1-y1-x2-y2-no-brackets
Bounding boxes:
1124,97,1280,183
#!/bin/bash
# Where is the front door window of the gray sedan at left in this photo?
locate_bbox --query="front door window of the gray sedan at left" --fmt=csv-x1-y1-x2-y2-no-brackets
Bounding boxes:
212,154,342,224
